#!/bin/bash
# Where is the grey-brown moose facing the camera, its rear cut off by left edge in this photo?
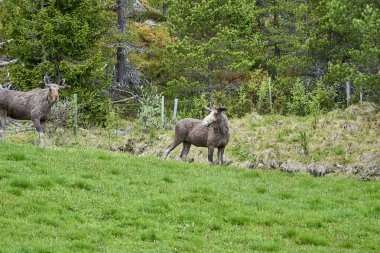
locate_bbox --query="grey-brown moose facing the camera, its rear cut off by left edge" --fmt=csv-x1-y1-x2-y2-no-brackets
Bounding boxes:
0,77,70,148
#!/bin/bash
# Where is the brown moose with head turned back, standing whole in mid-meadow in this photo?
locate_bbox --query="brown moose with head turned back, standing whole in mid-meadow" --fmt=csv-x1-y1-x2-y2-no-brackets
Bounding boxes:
163,105,230,164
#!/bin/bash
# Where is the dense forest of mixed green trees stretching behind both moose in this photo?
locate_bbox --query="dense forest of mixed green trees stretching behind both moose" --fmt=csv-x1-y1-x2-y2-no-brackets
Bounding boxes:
0,0,380,124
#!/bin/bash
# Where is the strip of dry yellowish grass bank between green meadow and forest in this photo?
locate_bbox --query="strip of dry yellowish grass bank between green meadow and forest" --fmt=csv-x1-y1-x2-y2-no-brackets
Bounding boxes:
3,105,380,178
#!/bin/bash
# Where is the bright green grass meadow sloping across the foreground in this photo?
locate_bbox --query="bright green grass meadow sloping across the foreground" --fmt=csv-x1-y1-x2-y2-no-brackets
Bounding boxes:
0,141,380,252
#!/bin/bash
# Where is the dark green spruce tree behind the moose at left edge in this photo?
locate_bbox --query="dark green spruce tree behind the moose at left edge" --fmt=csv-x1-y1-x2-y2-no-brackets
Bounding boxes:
0,0,116,121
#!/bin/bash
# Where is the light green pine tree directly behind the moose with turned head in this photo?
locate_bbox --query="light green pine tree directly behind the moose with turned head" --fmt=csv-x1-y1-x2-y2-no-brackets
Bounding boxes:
164,0,261,116
